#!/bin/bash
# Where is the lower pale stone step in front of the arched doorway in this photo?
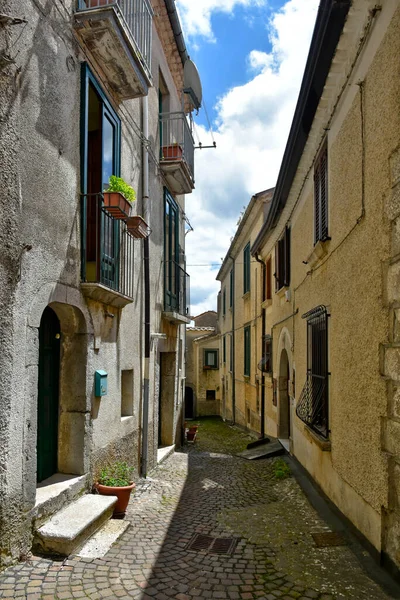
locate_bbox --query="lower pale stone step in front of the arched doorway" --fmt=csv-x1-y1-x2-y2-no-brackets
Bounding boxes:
34,494,117,556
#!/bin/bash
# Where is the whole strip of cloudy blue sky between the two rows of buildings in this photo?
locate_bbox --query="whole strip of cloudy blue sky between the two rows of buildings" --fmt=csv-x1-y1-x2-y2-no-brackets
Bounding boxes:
176,0,318,315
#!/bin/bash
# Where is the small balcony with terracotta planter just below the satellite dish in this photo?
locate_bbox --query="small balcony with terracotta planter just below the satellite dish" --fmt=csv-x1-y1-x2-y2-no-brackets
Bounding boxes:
160,112,194,194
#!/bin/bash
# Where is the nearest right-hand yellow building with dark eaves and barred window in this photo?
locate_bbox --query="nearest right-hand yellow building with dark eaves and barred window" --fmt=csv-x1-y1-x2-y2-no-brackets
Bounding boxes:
251,0,400,569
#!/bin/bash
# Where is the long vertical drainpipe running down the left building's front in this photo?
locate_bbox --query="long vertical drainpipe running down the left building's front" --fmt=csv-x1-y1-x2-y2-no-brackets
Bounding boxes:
141,96,150,477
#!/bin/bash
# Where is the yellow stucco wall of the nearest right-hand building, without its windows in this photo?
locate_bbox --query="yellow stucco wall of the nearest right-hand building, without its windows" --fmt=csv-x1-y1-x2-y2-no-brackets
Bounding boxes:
256,0,400,564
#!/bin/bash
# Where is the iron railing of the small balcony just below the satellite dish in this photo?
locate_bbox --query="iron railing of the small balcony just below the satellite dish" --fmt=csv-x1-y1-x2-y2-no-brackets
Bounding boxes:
160,112,194,180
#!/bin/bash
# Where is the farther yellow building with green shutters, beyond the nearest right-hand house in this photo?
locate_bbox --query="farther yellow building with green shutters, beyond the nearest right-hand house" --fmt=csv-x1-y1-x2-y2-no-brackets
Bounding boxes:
217,189,273,431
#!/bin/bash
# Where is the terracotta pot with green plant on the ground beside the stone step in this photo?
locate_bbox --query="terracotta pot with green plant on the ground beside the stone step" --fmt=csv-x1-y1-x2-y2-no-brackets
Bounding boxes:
94,462,136,519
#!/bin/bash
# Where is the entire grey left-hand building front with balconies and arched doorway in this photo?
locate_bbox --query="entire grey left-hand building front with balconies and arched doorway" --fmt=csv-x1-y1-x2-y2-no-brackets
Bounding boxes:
0,0,194,564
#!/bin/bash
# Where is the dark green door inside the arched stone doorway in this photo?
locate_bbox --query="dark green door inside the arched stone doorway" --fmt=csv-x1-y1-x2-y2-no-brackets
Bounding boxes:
37,307,60,481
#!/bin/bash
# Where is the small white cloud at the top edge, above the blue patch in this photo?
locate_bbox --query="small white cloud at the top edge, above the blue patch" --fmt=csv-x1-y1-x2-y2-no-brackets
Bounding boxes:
176,0,265,41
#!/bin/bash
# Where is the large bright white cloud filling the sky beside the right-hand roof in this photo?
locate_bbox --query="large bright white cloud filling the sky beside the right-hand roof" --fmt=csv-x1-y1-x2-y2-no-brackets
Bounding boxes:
184,0,318,314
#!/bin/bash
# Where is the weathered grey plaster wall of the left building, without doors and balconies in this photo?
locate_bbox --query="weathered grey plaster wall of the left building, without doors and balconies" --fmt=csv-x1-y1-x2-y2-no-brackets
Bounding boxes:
0,0,188,564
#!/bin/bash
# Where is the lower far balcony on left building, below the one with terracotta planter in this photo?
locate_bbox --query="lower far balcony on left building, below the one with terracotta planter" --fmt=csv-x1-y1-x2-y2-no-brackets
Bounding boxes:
163,260,191,325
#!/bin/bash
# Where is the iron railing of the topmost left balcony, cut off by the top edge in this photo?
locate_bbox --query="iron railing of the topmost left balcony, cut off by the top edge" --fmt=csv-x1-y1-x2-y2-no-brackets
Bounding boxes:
77,0,153,79
